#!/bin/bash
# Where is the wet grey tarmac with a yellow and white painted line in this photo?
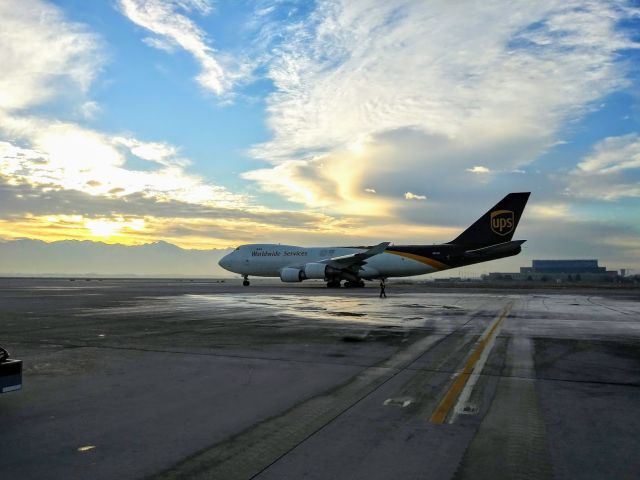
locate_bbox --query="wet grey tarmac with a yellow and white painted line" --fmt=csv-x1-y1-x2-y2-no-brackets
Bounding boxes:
0,279,640,480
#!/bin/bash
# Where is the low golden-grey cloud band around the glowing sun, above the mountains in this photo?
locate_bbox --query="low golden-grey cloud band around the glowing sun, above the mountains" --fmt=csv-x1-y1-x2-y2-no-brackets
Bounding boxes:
0,176,367,249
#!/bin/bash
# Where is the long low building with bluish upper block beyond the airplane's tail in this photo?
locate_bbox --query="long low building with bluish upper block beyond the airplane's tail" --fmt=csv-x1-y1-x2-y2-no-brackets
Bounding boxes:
484,260,618,282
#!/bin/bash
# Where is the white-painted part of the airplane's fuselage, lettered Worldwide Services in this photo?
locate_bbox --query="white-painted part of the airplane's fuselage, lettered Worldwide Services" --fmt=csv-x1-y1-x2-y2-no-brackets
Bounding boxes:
219,244,438,279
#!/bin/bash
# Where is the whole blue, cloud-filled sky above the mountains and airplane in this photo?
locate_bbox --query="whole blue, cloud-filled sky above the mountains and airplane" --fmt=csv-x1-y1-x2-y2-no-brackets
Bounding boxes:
0,0,640,271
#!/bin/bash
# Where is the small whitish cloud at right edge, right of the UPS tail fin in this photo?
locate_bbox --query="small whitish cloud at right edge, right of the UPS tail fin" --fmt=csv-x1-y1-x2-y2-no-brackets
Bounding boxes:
566,133,640,200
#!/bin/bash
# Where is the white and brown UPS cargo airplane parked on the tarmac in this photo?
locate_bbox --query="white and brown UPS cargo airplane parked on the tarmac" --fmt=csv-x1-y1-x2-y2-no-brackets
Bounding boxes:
219,192,530,288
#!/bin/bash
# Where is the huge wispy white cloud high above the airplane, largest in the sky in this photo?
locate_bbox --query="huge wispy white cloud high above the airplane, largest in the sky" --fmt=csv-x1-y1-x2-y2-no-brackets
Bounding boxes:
244,0,637,218
